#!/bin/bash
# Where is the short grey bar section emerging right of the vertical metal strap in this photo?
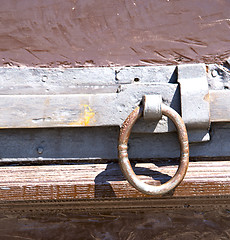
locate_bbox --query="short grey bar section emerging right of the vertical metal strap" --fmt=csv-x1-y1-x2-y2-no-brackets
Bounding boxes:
209,90,230,122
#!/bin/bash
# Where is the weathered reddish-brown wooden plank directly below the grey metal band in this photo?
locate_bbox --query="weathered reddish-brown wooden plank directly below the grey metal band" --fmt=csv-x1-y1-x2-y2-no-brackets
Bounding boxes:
0,161,230,202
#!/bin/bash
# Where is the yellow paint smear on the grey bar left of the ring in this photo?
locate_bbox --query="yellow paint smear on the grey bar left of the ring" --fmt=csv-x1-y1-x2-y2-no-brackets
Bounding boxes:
69,104,95,126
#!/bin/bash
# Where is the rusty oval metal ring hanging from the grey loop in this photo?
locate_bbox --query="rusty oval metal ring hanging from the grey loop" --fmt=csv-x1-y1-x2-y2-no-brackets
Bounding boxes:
118,104,189,195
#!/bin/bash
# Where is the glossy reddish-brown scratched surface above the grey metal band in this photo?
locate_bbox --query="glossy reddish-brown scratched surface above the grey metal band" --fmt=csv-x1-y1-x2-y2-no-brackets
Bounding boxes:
0,0,230,67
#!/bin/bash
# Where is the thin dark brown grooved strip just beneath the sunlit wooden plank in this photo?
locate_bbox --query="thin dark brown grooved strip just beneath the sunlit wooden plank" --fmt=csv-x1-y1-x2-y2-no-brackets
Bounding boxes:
0,196,230,216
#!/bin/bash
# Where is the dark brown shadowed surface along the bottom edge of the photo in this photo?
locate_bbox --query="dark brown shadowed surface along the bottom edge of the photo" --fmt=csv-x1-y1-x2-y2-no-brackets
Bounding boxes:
0,209,230,240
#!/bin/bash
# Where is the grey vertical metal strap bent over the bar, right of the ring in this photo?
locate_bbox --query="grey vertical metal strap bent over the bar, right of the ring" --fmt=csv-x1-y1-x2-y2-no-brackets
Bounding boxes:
178,64,210,142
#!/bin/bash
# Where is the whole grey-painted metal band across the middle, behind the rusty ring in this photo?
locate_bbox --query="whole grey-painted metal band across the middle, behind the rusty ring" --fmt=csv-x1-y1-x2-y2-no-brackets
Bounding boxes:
0,64,230,162
